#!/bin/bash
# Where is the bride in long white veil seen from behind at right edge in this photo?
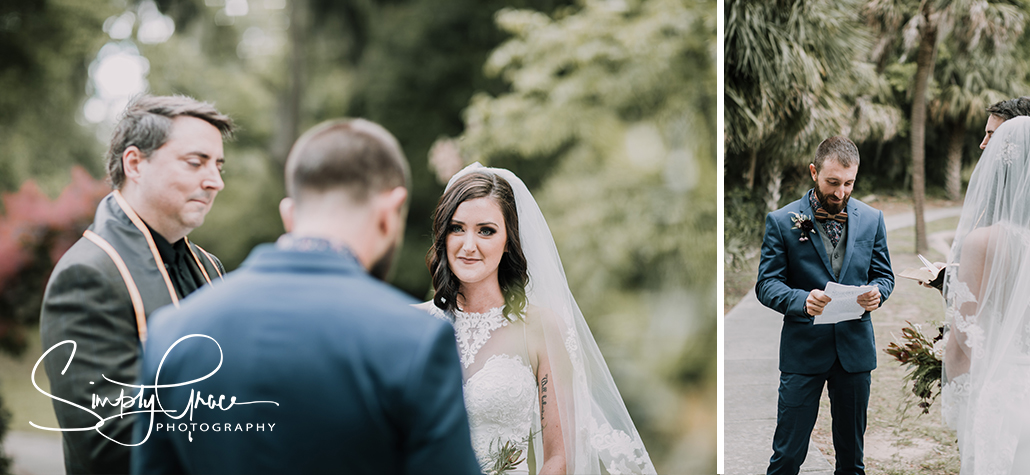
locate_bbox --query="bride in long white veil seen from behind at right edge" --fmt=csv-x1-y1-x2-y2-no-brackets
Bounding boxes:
942,117,1030,475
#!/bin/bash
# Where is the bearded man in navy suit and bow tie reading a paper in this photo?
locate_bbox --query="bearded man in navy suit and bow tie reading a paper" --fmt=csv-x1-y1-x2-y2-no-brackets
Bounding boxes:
755,137,894,474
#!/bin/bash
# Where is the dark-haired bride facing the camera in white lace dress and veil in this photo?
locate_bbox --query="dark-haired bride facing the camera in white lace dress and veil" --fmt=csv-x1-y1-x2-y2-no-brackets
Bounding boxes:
419,163,655,474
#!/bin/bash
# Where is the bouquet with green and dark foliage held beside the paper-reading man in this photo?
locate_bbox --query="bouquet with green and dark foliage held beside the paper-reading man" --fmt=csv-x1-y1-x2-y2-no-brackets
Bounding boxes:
884,320,947,414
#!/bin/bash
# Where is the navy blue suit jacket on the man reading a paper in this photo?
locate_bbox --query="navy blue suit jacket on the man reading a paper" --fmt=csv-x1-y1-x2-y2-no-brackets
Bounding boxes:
755,191,894,374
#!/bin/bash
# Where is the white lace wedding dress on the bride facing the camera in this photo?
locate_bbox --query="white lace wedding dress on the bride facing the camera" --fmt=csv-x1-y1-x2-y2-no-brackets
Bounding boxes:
417,302,540,474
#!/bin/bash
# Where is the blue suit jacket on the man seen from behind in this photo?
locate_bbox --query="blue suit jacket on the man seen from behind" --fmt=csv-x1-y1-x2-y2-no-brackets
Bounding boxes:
133,244,480,475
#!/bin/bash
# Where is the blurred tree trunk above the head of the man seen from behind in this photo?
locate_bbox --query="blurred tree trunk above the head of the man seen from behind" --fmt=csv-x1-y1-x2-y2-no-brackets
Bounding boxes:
272,0,311,165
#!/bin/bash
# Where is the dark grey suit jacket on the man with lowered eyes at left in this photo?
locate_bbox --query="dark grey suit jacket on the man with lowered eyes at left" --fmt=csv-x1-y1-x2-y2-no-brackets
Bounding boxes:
39,192,225,474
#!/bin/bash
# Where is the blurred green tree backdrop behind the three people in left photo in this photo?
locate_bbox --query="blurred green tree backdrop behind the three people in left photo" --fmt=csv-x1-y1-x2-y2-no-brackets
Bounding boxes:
0,0,717,467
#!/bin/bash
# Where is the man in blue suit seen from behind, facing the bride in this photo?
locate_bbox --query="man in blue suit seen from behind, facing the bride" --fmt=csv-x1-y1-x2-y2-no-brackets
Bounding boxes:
132,120,480,474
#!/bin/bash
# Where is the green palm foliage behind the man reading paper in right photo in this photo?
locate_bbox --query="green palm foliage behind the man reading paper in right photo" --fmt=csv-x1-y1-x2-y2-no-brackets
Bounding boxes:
724,0,1030,260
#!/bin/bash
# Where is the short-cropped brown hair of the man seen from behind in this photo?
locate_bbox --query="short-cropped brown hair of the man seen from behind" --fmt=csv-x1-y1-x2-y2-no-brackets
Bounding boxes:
286,118,411,204
